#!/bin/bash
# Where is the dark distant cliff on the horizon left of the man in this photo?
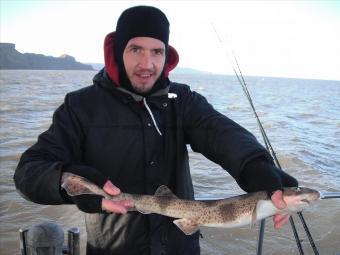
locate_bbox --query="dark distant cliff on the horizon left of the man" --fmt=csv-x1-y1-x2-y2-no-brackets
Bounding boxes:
0,43,93,70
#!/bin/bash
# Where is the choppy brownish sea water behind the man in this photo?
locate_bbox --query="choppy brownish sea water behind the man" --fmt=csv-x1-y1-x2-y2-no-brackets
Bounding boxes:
0,70,340,255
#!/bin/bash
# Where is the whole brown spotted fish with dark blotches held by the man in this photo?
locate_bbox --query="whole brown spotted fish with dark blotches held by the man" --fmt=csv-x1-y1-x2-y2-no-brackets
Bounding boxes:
62,173,320,235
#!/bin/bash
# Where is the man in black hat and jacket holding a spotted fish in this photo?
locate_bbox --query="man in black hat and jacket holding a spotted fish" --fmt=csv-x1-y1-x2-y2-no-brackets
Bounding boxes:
14,6,297,254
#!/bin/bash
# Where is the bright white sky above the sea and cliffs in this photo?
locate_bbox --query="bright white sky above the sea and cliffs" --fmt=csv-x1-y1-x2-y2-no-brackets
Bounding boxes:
0,0,340,80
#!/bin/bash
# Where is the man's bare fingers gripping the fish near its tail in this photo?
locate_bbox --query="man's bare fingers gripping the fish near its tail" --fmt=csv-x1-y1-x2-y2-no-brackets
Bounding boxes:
102,181,134,214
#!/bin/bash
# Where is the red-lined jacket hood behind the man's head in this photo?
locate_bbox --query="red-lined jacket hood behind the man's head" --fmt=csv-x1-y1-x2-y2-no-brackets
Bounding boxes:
104,32,179,86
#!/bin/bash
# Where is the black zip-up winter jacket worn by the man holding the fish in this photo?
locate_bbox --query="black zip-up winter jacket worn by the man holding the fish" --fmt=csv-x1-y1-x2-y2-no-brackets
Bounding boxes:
14,32,268,255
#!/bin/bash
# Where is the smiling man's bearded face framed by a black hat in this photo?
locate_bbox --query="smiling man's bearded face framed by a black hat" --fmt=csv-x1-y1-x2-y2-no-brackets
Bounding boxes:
123,37,166,93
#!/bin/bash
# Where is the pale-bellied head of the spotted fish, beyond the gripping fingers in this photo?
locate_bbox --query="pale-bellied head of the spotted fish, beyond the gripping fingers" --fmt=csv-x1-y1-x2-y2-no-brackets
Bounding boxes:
283,187,320,212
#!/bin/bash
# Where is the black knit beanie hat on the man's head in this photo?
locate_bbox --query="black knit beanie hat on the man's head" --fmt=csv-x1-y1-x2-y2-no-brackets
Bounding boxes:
115,6,169,62
